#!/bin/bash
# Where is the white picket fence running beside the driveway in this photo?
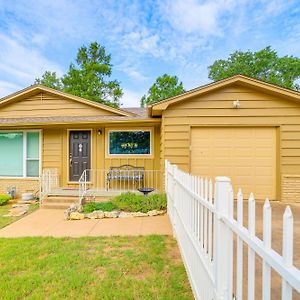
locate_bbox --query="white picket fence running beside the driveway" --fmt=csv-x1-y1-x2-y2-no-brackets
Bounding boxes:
165,161,300,300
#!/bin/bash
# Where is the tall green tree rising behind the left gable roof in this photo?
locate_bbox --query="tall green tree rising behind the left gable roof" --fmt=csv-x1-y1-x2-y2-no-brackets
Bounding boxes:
35,42,123,107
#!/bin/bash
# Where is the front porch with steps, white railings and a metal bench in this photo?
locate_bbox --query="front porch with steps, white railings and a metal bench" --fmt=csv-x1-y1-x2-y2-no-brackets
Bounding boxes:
40,168,161,209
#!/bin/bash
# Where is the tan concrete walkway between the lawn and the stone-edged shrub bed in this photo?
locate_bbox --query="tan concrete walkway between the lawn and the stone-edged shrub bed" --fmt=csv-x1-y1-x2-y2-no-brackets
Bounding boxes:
0,209,172,237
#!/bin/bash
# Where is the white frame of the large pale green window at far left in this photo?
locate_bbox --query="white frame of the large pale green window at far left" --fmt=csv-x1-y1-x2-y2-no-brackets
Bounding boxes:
0,129,42,179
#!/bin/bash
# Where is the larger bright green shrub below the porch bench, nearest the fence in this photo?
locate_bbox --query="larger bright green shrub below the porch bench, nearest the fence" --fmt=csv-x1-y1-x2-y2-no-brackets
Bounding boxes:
112,192,167,213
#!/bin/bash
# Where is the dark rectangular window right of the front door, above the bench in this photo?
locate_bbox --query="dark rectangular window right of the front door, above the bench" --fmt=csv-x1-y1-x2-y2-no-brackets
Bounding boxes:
108,130,151,155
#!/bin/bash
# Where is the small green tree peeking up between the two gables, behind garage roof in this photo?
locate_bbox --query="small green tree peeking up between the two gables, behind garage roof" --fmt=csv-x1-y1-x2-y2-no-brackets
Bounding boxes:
140,74,185,107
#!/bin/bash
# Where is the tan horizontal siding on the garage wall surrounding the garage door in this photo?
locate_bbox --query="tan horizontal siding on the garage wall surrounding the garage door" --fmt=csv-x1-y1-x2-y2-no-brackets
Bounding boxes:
161,85,300,201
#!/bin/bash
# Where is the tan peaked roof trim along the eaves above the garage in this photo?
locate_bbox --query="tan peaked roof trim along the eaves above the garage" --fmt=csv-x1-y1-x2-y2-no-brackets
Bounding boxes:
148,75,300,116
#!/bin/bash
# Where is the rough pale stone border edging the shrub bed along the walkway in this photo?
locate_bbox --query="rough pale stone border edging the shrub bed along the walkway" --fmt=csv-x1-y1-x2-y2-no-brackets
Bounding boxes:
65,206,166,220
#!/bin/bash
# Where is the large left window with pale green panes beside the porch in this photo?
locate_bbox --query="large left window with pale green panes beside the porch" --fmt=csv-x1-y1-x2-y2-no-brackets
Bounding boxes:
0,131,40,177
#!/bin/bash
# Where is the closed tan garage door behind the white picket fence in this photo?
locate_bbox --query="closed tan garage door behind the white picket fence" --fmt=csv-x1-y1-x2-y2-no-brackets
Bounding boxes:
191,127,276,200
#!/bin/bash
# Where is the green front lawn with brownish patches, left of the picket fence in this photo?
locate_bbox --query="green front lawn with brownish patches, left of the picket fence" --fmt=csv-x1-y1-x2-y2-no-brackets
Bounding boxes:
0,235,193,299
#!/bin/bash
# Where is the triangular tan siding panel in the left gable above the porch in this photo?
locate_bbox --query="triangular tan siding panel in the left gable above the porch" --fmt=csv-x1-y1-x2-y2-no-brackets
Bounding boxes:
0,93,115,118
